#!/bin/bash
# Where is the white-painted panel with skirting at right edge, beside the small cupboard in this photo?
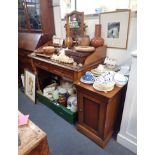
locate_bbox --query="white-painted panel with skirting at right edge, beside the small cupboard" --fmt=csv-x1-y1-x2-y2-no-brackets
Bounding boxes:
117,51,137,153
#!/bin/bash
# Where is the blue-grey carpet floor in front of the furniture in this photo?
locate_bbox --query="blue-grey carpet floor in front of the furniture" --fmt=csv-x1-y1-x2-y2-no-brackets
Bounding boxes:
18,90,135,155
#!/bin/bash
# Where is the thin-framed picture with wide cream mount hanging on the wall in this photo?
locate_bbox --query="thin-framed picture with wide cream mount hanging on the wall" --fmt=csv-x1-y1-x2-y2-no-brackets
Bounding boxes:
99,9,131,49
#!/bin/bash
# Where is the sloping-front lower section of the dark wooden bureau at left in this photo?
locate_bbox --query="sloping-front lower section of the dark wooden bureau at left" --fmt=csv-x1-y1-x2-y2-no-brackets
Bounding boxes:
18,33,52,84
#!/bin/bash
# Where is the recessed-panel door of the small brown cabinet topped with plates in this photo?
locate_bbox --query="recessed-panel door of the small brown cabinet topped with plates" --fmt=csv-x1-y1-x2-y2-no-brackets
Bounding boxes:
78,93,106,137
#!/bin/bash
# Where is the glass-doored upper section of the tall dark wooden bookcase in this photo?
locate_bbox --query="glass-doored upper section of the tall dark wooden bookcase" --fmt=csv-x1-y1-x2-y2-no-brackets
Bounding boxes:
18,0,55,34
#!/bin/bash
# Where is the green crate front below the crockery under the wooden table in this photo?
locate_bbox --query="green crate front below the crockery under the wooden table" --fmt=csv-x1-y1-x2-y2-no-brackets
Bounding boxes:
37,92,77,124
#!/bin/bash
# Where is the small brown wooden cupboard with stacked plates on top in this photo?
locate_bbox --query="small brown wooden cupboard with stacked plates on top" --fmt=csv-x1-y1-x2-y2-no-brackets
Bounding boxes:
76,82,126,147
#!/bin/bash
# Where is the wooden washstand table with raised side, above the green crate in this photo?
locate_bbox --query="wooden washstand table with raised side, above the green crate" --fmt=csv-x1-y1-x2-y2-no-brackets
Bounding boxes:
29,46,106,86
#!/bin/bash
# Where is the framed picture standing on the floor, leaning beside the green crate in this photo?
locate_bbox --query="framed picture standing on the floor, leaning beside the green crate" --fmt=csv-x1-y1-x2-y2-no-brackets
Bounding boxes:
24,69,36,103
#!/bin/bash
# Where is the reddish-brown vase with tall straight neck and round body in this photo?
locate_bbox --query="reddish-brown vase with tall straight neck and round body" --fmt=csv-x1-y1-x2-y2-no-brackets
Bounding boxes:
91,24,104,48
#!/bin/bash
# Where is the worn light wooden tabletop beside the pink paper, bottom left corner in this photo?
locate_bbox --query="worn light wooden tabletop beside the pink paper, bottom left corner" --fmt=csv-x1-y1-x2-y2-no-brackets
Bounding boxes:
18,112,46,155
